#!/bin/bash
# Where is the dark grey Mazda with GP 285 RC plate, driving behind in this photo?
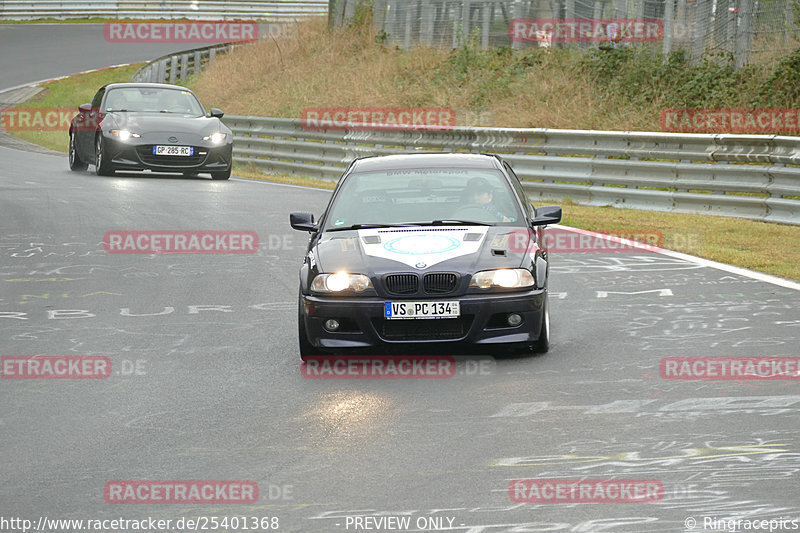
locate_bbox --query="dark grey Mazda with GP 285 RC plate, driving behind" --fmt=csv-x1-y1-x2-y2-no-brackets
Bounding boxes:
69,83,233,180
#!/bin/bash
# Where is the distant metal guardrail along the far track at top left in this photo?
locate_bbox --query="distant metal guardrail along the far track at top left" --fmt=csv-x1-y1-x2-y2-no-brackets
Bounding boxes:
0,0,328,22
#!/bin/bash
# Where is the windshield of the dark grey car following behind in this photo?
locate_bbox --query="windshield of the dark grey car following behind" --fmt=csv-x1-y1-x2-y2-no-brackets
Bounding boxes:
103,87,205,116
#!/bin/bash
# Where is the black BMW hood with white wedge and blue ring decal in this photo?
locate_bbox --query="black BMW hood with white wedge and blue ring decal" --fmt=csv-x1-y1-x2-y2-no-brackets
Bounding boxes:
312,226,536,276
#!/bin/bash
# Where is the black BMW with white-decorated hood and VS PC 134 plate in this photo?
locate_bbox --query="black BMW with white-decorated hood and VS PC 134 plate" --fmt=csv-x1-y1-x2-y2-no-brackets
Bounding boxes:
290,153,561,359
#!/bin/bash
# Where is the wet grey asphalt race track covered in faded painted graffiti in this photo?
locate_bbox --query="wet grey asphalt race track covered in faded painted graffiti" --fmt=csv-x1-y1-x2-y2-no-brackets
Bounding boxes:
0,26,800,533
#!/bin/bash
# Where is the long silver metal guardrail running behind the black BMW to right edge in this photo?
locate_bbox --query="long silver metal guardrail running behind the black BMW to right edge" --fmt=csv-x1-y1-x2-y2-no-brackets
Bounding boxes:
223,116,800,225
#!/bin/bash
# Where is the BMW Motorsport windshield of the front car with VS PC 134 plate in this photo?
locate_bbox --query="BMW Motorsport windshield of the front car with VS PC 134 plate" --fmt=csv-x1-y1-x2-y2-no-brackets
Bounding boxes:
325,168,522,230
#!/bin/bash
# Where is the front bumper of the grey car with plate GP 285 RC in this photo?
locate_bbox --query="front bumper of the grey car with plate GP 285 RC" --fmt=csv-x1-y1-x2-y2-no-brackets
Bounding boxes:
104,136,233,172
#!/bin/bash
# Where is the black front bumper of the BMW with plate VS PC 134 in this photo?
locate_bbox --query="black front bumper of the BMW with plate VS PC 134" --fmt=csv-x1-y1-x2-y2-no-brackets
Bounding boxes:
300,289,546,349
